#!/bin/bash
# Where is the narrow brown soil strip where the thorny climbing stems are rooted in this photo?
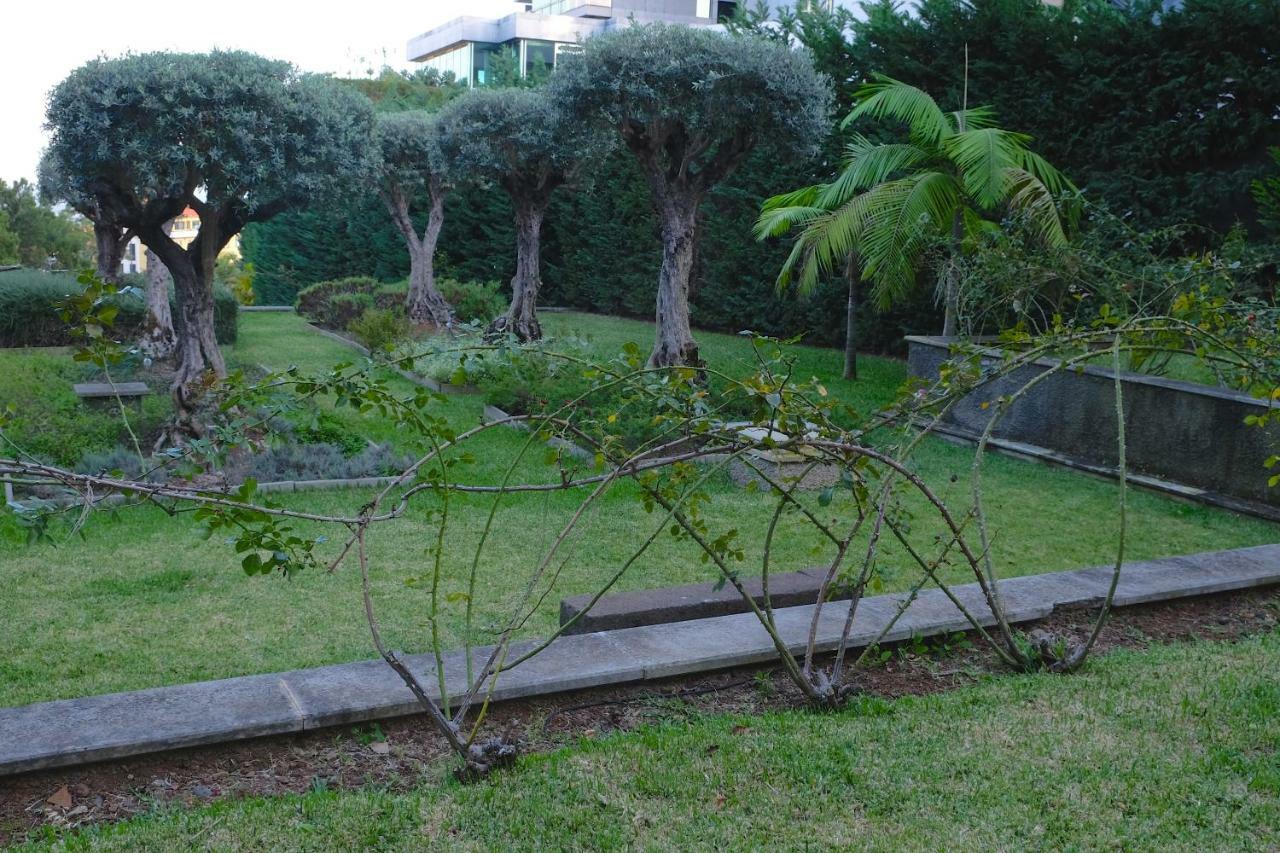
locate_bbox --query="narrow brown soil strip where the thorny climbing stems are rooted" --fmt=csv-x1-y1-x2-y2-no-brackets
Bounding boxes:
0,588,1280,843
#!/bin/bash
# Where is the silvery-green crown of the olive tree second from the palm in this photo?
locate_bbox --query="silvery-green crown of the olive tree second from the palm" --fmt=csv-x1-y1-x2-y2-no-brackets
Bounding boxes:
439,88,608,196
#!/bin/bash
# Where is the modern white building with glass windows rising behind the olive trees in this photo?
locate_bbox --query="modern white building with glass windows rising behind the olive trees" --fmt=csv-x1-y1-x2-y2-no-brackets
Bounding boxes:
408,0,847,86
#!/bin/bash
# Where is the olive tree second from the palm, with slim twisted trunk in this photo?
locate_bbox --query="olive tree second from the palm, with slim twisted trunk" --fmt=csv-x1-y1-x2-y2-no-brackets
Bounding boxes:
439,88,605,341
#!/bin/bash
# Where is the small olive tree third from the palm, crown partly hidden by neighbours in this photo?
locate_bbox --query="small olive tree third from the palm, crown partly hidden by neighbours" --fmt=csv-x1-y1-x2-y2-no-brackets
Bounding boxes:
374,110,453,327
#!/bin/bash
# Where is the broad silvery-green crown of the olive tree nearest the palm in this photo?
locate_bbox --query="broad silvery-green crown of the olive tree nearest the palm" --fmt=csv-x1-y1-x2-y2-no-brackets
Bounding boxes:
550,23,832,181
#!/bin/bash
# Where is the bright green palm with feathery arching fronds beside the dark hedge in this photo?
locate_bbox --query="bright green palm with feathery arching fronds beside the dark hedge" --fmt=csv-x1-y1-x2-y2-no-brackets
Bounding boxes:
755,76,1075,361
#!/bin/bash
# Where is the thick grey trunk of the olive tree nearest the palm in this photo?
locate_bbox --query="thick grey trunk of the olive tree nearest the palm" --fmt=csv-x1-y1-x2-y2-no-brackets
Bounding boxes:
649,199,703,368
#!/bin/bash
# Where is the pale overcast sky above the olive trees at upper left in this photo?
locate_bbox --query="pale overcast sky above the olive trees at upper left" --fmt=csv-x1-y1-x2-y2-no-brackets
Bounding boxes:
0,0,516,181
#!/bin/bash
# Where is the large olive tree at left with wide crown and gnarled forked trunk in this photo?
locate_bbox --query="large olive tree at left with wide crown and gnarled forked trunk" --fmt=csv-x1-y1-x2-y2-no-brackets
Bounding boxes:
46,51,372,417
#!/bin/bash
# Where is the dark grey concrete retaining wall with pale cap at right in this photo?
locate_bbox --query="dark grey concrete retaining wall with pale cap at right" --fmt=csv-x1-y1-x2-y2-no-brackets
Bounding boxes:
906,336,1280,507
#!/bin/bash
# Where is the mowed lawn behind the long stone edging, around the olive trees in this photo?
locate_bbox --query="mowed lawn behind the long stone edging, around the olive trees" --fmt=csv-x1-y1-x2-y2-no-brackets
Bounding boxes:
0,314,1277,706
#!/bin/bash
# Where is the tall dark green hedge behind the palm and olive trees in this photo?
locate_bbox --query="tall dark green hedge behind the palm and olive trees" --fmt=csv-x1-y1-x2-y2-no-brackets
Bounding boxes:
244,0,1280,350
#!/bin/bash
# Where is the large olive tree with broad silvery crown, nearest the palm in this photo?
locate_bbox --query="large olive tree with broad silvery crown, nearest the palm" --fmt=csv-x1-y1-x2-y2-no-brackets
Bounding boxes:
550,24,831,366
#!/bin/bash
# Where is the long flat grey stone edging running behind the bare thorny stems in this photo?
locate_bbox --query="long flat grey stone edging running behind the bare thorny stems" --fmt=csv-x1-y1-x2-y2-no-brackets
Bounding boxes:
0,544,1280,776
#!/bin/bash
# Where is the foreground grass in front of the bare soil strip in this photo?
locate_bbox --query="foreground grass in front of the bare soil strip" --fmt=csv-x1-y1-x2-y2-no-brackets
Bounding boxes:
17,633,1280,850
